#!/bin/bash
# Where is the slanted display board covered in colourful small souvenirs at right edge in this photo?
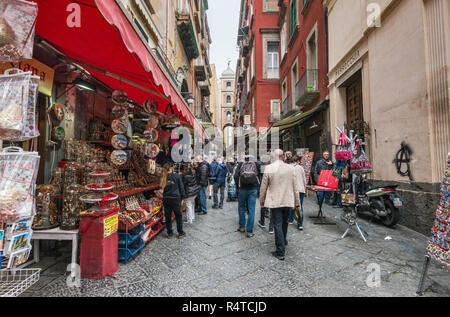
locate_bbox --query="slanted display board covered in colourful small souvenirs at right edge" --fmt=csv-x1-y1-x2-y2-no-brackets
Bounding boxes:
427,153,450,267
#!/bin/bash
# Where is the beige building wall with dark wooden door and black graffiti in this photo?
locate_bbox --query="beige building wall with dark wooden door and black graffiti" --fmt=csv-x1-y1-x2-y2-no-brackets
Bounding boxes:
324,0,450,234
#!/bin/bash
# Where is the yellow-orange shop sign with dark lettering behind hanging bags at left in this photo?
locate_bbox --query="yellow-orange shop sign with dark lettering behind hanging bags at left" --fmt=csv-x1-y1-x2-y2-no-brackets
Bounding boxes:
0,58,55,96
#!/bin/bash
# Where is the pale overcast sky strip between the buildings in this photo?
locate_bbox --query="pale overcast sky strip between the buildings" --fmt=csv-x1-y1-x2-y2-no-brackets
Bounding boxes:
207,0,241,78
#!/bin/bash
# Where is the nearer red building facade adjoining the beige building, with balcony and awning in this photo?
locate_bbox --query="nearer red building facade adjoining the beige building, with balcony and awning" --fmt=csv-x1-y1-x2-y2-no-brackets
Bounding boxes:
272,0,331,156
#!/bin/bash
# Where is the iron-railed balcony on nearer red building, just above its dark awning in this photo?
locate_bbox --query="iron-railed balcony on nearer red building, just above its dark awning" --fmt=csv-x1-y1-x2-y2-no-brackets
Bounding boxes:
295,69,320,107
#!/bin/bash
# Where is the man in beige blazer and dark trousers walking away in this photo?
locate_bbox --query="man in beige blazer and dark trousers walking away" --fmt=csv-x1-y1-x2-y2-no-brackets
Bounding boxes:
260,150,300,260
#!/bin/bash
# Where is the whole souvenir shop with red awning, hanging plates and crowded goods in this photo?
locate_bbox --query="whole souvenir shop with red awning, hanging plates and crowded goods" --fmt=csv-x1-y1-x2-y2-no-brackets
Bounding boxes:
0,0,204,297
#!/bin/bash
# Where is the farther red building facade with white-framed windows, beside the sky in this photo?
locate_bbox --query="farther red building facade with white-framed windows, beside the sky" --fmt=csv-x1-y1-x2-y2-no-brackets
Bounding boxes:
236,0,280,129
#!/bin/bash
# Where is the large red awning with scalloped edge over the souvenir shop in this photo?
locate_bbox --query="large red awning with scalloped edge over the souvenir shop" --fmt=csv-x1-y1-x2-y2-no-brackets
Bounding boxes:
33,0,204,136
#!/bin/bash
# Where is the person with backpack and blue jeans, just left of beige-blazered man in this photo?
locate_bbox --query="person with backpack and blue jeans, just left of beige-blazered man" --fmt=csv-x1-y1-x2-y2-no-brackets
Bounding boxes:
234,156,261,238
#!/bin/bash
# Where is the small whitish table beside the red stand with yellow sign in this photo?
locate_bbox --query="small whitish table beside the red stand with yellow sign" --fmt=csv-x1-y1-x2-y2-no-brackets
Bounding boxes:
21,227,78,268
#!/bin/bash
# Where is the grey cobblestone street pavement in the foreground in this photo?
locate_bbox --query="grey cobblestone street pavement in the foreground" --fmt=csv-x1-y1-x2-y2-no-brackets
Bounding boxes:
23,198,450,297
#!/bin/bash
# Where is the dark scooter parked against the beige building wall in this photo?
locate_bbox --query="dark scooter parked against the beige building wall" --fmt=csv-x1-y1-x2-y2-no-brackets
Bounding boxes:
342,175,403,228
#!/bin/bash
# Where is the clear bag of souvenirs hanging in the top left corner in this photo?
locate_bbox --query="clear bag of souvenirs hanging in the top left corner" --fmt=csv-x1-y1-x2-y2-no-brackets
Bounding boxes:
0,0,38,62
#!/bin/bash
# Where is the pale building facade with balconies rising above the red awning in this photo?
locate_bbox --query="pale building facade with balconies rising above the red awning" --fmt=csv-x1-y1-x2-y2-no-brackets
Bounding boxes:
119,0,212,123
